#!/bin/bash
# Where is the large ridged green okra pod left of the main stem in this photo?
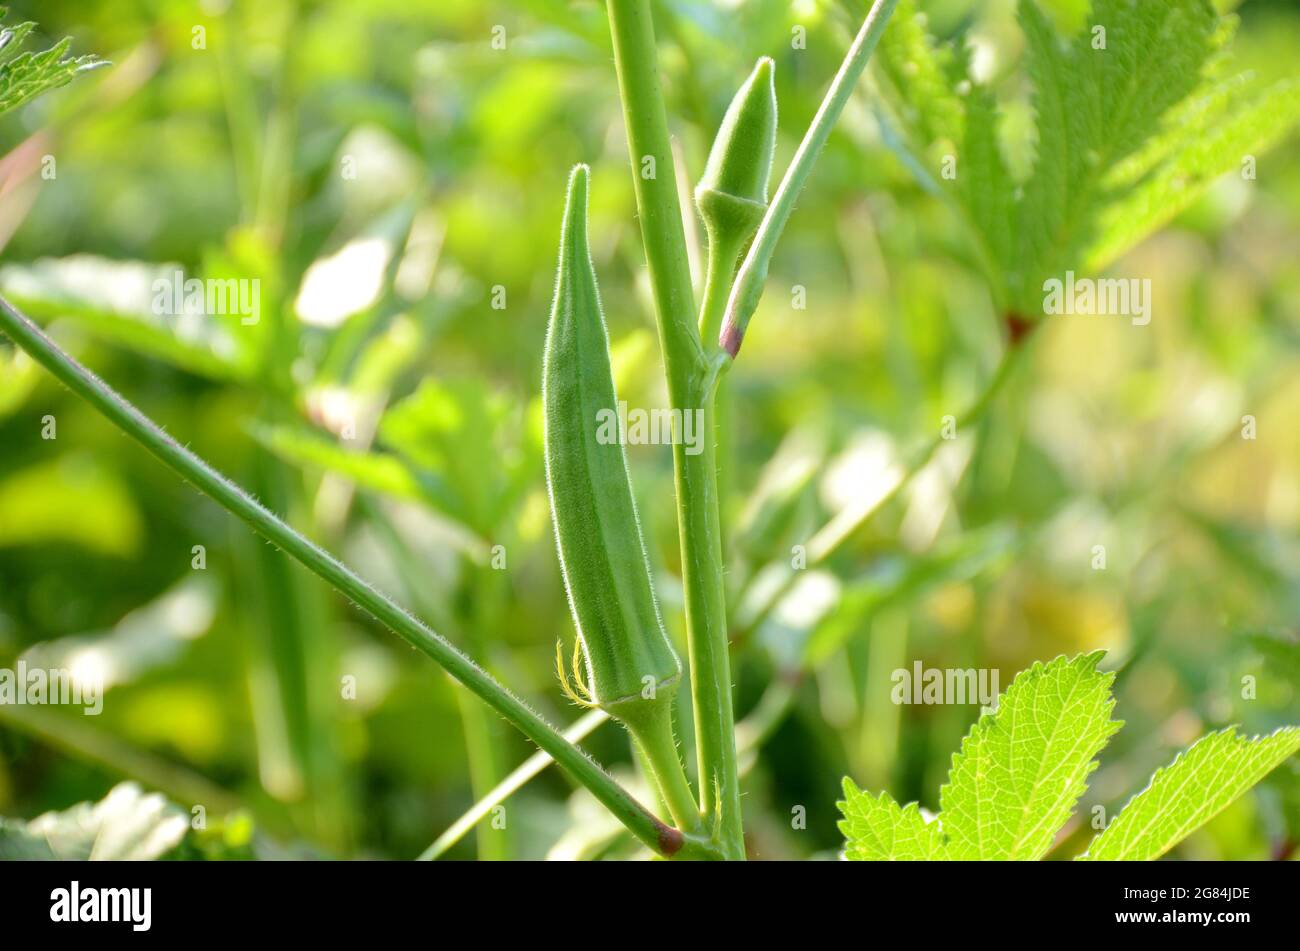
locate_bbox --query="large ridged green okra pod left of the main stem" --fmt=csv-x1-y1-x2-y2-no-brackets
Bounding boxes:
542,165,681,731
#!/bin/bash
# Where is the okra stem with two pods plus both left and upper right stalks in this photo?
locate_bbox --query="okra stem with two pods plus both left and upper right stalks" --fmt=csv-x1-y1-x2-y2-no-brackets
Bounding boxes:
0,0,897,859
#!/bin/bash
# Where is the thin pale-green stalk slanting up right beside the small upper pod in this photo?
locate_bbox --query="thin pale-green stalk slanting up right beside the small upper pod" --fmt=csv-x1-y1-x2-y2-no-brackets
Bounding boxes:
718,0,898,357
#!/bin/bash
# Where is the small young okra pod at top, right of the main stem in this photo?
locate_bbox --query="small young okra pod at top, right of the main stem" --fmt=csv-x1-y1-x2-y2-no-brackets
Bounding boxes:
696,56,776,248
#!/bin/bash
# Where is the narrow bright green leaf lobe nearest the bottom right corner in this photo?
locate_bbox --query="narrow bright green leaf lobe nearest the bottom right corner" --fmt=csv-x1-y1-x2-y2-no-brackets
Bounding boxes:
1079,726,1300,861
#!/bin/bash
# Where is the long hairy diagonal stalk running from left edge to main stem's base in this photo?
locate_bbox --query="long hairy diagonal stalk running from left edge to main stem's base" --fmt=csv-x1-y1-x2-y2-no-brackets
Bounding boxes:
0,296,720,859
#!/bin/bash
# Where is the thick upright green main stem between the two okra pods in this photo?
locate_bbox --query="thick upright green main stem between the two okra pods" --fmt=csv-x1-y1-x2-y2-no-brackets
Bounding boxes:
608,0,745,859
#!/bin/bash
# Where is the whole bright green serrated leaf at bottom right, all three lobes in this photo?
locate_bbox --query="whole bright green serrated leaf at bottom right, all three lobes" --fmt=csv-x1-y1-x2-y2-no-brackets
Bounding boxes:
839,651,1300,860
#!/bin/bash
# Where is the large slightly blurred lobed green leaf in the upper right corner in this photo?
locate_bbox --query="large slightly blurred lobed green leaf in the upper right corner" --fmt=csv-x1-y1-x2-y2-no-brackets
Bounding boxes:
876,0,1300,317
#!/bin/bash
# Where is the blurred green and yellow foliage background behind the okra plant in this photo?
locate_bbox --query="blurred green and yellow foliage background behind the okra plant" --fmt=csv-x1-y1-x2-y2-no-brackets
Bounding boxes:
0,0,1300,859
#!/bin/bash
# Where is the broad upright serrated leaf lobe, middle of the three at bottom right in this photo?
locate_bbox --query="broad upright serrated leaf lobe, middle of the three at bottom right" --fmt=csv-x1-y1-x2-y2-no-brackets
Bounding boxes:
939,651,1122,860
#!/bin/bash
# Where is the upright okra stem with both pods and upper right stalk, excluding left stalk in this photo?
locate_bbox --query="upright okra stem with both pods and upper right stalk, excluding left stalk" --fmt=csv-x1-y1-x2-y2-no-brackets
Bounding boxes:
533,0,896,859
